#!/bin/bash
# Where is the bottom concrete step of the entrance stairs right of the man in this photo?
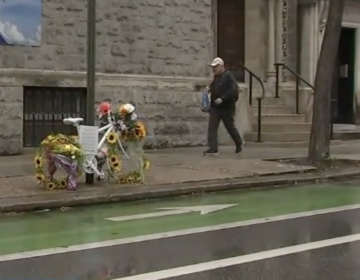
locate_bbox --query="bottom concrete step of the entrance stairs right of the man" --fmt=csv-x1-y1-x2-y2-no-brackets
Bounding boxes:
244,132,310,142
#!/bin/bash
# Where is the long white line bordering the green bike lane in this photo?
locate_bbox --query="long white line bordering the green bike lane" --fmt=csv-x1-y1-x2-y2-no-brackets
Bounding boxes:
0,204,360,262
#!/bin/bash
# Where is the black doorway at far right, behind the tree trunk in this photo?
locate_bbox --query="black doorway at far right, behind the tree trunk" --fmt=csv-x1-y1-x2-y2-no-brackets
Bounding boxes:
332,28,355,124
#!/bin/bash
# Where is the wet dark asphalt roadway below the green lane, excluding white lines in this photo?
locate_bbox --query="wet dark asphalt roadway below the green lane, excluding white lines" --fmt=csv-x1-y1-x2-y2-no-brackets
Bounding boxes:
0,207,360,280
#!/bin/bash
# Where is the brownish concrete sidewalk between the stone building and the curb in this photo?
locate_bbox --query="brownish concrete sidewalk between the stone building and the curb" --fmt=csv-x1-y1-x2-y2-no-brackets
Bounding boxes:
0,141,360,211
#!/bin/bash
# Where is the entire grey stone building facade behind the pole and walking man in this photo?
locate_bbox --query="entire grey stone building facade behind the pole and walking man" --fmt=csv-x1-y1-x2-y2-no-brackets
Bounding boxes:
0,0,360,155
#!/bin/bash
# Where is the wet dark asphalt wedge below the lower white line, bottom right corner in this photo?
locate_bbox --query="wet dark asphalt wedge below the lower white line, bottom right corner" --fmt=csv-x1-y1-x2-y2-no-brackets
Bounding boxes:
165,242,360,280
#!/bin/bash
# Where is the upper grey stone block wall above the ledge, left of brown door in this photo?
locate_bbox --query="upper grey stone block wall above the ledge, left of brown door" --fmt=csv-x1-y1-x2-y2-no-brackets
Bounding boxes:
0,0,214,77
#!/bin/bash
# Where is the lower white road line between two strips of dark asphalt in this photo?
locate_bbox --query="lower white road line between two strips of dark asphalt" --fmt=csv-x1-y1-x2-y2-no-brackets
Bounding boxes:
118,234,360,280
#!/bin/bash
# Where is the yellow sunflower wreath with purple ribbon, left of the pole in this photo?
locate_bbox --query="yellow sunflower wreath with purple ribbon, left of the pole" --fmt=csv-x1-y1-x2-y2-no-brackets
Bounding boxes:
34,134,83,190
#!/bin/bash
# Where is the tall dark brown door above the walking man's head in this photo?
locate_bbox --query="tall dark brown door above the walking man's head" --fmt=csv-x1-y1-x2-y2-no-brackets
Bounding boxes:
217,0,245,81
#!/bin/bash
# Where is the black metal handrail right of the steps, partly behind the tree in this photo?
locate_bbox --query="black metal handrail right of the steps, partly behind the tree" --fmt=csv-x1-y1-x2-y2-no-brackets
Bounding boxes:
274,63,337,140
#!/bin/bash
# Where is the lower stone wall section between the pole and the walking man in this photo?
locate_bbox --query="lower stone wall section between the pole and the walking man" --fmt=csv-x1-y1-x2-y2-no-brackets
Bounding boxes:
97,76,208,148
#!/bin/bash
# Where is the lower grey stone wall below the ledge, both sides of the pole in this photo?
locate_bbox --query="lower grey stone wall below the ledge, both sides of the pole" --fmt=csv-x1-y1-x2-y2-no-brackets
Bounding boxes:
0,70,209,155
